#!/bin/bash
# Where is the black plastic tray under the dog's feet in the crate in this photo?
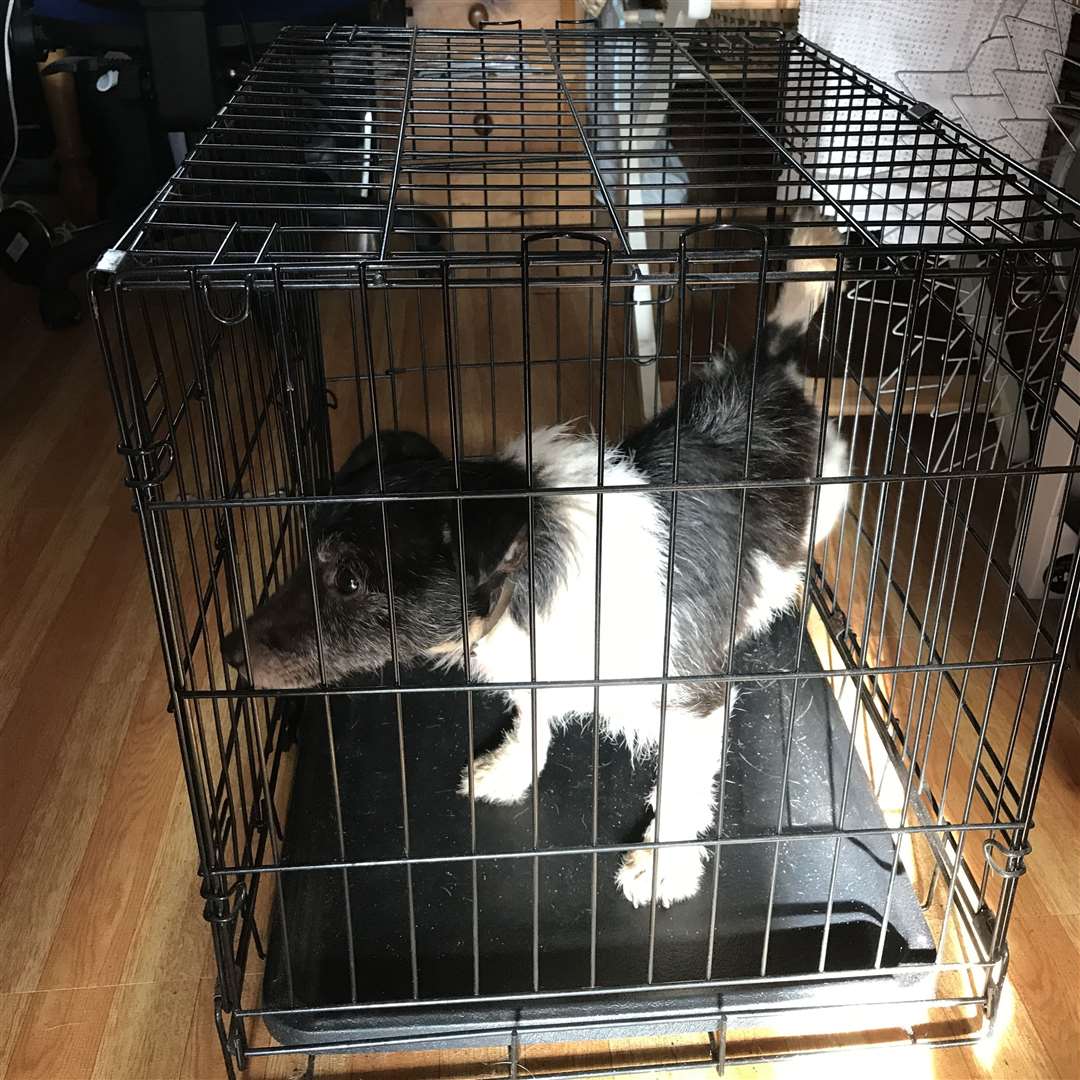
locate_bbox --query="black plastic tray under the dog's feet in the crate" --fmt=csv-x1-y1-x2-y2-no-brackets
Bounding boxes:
262,618,934,1044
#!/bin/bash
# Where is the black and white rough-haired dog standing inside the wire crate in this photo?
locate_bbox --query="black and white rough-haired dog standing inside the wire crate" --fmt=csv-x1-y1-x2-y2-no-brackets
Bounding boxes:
222,227,848,906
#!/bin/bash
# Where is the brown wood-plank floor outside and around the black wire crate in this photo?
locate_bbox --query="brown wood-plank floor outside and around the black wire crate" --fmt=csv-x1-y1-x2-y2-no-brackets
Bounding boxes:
0,270,1080,1080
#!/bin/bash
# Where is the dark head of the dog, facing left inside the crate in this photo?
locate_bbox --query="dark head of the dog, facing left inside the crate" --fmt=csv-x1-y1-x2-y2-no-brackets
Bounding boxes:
221,433,527,689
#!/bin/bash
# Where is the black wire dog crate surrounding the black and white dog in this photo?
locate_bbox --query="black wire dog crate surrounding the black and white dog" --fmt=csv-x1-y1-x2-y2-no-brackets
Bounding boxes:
92,25,1080,1077
